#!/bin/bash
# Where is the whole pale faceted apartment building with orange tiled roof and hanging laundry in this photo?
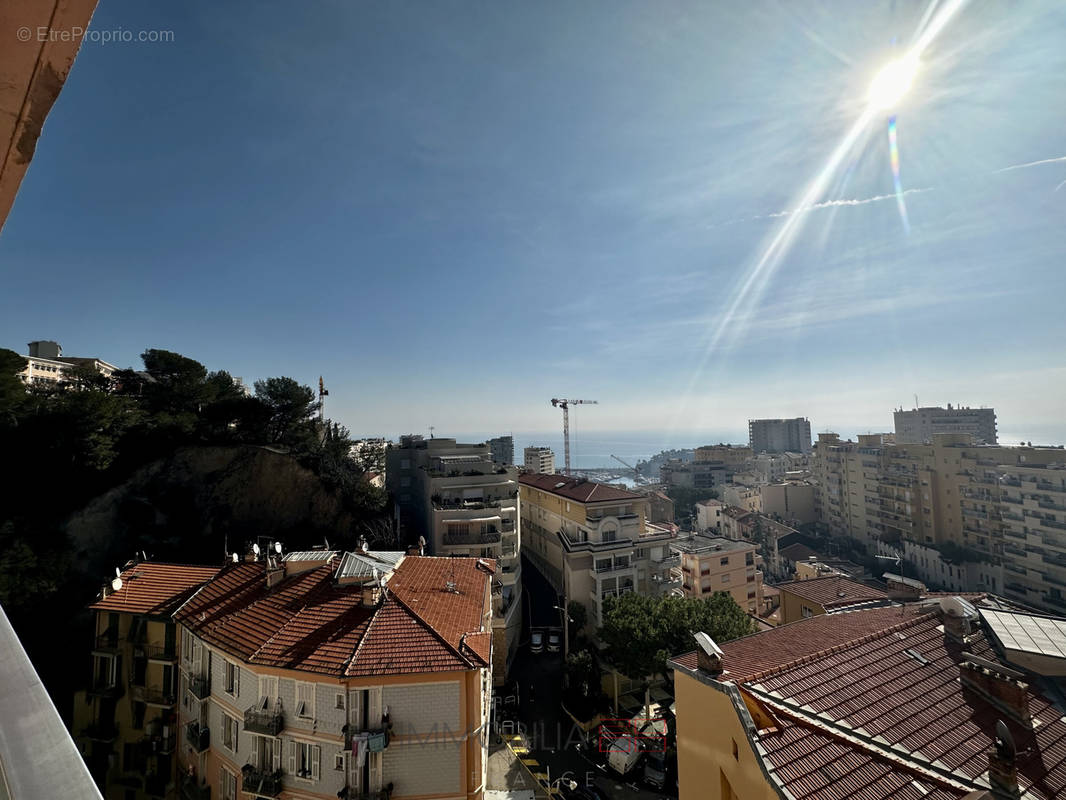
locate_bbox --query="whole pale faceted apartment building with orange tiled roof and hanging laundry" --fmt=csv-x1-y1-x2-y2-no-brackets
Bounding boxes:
175,550,495,800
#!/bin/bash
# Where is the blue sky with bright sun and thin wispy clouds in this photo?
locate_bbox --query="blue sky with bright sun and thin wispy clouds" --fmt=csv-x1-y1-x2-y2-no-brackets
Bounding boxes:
0,0,1066,444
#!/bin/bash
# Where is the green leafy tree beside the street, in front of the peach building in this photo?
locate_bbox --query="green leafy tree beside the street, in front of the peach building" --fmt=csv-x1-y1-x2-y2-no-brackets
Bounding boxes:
600,592,755,716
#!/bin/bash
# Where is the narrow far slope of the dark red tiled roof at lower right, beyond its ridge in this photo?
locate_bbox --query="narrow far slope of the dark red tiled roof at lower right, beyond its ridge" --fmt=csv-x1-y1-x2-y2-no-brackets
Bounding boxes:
673,605,931,682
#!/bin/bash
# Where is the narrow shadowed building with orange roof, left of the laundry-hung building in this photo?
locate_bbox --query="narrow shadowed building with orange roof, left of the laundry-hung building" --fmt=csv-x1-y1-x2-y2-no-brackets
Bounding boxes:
71,561,219,800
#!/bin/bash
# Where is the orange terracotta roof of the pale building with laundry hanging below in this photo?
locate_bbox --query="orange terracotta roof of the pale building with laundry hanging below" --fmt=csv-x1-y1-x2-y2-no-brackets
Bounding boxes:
175,556,496,676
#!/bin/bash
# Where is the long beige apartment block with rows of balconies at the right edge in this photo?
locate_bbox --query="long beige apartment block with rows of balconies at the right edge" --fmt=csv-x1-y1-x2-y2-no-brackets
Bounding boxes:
813,433,1066,611
